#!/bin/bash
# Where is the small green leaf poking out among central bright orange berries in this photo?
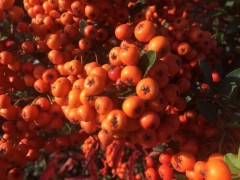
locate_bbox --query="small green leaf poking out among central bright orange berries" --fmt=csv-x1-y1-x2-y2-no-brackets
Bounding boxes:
137,50,157,77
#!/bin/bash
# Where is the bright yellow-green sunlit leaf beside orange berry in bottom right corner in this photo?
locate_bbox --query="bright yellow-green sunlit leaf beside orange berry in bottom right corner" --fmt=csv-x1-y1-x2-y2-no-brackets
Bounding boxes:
224,153,240,174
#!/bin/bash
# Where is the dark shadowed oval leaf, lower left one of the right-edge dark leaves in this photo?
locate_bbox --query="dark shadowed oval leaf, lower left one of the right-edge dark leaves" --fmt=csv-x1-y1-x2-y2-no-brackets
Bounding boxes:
196,99,217,122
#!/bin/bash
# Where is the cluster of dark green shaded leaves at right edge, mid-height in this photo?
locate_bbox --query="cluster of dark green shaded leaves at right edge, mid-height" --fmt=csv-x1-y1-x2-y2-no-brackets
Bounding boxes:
196,61,240,124
